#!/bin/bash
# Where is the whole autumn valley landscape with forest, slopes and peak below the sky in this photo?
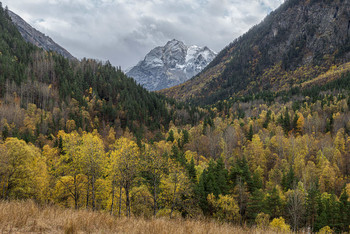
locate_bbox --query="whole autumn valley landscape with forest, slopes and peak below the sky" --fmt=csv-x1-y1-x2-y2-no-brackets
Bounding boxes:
0,0,350,233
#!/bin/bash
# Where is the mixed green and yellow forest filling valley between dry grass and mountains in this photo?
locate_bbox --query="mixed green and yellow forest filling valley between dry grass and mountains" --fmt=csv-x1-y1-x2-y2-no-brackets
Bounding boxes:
0,1,350,232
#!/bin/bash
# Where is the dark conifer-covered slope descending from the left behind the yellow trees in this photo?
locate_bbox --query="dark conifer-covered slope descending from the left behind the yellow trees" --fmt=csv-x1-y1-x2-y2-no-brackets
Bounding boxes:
0,5,198,142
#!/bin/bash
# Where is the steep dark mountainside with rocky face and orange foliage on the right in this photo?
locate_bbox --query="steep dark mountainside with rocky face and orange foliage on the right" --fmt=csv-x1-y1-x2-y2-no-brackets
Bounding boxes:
161,0,350,104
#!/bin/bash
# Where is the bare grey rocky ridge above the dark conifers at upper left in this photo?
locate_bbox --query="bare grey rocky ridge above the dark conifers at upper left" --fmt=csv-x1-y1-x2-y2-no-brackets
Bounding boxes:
9,11,75,59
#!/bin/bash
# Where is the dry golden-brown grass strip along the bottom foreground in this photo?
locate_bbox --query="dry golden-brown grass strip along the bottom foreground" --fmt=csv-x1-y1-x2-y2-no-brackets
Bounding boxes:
0,201,284,234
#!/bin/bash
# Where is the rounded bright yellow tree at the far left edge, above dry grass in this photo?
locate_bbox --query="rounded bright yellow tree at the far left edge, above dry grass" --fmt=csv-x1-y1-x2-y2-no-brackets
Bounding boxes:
0,138,48,201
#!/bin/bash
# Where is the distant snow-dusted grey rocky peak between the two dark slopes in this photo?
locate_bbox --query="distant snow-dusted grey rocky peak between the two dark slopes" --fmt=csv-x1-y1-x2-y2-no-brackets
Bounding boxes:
127,39,216,91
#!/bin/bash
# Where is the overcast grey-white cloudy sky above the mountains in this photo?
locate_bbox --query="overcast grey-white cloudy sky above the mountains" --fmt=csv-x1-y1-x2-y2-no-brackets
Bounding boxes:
0,0,284,69
